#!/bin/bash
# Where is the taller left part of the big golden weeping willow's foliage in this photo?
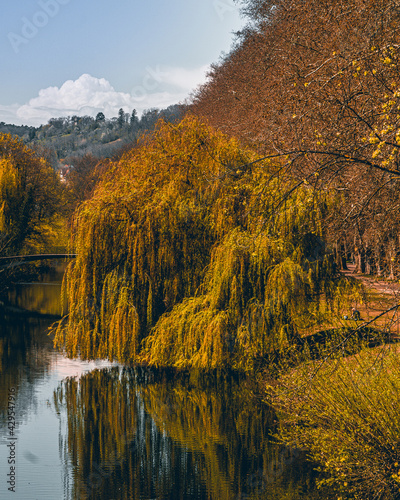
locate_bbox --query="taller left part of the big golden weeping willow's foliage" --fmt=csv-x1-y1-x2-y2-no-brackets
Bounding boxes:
52,117,256,360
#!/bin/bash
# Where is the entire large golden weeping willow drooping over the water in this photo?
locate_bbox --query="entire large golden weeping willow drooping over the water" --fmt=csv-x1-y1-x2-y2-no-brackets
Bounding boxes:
55,116,354,369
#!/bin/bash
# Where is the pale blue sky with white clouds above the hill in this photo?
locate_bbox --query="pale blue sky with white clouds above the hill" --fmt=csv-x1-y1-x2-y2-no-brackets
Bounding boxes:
0,0,244,125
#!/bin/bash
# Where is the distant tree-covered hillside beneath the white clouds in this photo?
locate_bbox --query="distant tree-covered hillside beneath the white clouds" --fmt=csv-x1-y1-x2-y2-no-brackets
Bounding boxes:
0,104,184,168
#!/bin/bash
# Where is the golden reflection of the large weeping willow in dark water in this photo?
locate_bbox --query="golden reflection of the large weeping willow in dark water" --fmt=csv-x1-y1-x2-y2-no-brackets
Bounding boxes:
54,367,317,500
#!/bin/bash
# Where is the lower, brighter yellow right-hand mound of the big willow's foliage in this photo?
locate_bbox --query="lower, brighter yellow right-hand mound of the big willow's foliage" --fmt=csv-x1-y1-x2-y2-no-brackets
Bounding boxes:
143,224,331,370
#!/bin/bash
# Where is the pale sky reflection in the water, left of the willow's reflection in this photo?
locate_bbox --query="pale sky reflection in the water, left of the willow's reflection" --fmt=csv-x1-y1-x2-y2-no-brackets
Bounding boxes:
0,336,117,500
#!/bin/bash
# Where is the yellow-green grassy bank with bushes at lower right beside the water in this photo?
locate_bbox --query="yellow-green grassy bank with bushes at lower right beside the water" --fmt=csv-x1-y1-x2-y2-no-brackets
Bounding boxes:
266,276,400,500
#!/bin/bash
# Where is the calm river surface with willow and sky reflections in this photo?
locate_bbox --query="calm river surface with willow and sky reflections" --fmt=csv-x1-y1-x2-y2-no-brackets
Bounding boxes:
0,275,318,500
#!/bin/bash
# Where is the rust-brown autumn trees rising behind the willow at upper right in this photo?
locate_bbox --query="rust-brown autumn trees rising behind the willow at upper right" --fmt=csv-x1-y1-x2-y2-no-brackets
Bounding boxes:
192,0,400,274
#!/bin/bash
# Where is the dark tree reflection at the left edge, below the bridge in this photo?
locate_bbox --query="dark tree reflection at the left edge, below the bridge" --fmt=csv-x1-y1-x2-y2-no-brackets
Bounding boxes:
0,266,63,421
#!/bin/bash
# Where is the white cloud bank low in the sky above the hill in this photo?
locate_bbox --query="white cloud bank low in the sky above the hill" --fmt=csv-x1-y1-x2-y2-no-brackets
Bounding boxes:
0,66,207,126
